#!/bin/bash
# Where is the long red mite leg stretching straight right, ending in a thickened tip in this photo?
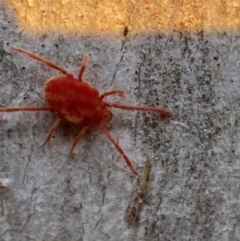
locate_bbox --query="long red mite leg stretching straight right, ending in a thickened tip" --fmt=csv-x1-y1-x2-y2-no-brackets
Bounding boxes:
107,103,173,116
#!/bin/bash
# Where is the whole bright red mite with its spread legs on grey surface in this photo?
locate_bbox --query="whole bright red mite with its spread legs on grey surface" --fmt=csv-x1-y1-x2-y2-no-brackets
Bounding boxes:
0,47,172,175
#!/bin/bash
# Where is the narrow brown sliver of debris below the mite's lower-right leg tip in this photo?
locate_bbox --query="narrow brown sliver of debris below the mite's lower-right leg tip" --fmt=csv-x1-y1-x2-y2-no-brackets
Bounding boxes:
125,157,151,226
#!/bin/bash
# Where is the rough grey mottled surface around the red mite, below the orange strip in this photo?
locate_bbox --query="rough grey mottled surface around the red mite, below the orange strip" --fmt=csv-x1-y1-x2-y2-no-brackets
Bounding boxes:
0,3,240,241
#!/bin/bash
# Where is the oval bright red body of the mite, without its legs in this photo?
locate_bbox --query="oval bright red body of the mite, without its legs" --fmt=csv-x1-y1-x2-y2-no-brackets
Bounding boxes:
44,76,112,126
